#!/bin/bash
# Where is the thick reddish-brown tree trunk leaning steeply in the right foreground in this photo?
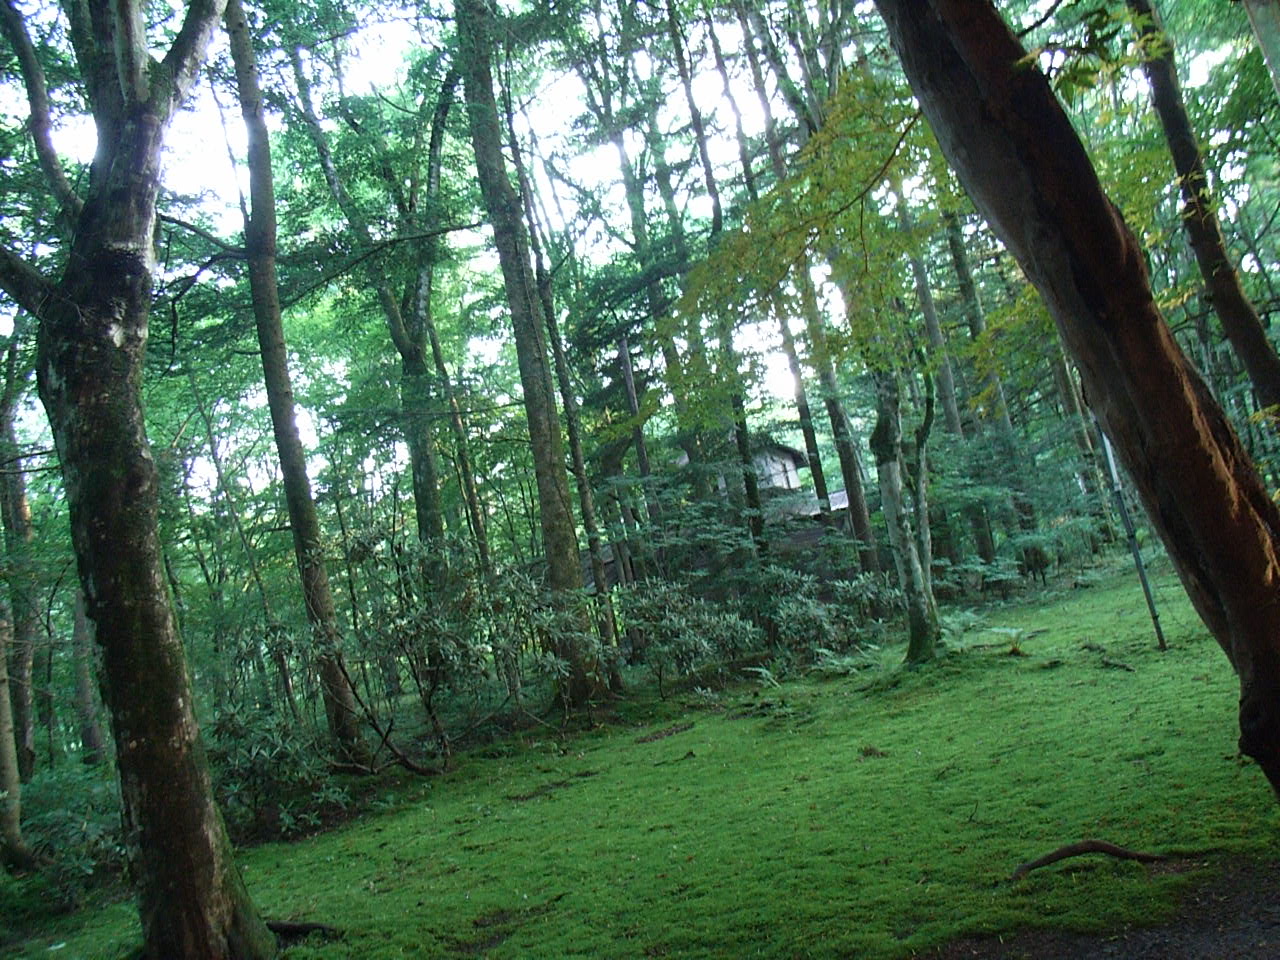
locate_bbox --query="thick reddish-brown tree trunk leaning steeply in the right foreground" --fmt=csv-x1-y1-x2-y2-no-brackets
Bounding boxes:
877,0,1280,795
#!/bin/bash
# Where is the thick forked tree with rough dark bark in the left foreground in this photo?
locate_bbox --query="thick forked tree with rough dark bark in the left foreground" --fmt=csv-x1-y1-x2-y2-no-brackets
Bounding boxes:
0,0,275,960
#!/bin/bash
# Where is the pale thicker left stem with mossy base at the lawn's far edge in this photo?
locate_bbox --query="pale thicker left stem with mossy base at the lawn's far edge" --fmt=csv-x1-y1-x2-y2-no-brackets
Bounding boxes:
870,371,940,663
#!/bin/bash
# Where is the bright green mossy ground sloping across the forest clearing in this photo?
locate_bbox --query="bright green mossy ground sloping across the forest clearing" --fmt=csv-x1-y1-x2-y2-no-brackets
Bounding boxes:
10,560,1280,960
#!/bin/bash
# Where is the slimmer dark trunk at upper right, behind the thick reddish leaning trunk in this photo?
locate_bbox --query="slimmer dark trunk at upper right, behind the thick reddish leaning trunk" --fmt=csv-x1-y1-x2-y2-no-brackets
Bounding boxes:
1126,0,1280,416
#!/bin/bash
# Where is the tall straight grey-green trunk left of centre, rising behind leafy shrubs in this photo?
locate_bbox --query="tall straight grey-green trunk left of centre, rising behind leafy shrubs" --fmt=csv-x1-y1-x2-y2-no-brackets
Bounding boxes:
454,0,605,708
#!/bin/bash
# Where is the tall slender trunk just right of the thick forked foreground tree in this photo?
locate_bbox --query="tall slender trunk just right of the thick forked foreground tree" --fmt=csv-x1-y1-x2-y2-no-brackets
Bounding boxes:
227,0,365,763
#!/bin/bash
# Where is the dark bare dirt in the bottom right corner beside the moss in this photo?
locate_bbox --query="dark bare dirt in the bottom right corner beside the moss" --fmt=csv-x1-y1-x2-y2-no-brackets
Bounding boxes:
924,860,1280,960
